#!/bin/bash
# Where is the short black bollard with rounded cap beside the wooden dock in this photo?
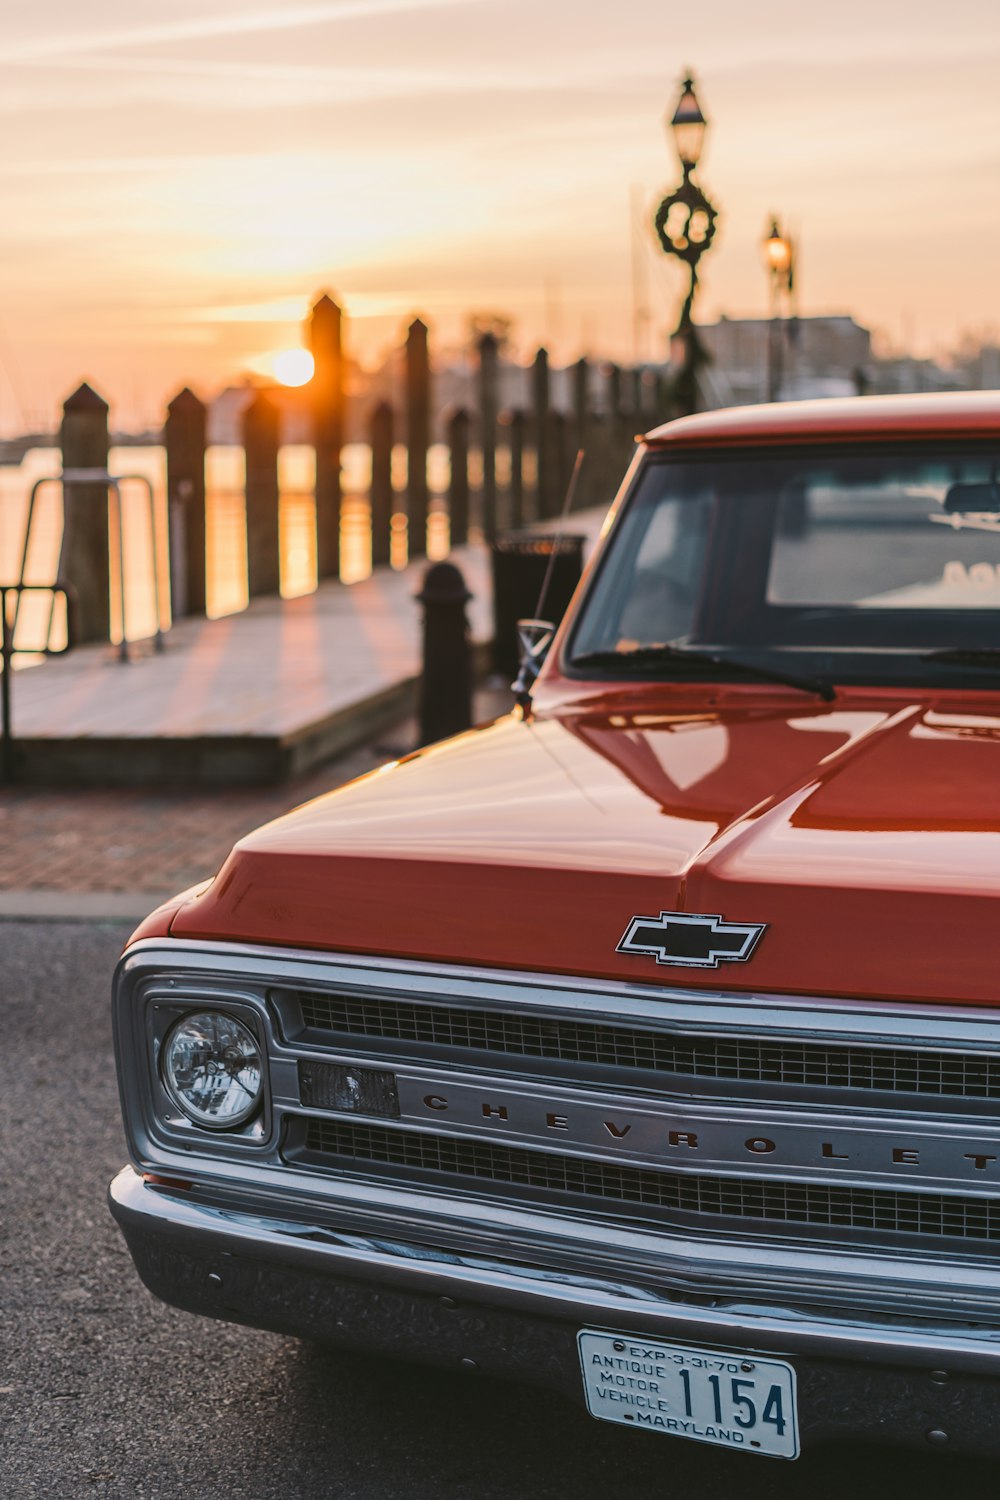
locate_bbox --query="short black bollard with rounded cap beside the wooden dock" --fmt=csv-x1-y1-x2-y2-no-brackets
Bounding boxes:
417,563,472,746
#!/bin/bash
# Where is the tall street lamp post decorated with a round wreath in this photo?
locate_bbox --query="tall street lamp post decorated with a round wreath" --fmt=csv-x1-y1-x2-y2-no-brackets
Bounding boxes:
654,77,718,414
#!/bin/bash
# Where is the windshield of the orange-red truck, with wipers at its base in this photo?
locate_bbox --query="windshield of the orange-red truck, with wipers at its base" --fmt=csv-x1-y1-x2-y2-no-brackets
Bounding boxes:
567,443,1000,686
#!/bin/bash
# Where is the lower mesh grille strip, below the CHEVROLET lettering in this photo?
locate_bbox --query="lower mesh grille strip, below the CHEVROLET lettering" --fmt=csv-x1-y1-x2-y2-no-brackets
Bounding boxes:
292,1119,1000,1244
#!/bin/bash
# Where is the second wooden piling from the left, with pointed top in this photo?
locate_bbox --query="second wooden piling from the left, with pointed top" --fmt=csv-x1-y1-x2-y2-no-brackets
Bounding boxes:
163,386,207,620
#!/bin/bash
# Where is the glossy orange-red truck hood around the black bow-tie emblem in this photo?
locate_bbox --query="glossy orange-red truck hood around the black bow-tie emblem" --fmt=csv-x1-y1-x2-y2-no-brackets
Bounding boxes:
171,689,1000,1004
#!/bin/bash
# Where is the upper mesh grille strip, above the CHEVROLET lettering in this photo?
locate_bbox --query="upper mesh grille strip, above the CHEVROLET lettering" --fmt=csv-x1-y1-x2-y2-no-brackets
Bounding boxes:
283,992,1000,1100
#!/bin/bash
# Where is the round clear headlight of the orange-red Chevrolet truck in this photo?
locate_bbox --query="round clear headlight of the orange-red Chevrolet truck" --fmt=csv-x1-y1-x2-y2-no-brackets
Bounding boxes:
160,1011,264,1130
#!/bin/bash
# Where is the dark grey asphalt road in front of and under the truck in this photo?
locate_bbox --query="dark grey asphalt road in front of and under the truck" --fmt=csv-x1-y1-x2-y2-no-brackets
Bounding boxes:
0,923,1000,1500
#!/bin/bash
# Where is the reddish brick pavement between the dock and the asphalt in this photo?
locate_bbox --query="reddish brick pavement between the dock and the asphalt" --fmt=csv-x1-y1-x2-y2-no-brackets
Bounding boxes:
0,690,510,905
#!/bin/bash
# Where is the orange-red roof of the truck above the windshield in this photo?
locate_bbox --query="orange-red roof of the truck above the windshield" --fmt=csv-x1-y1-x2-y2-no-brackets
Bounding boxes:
645,390,1000,449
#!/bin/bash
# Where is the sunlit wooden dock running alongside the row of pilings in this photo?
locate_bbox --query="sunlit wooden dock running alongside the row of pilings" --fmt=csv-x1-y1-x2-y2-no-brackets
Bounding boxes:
12,512,603,786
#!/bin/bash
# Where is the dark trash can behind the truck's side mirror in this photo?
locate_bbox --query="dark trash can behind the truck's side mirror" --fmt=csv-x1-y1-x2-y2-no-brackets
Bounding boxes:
492,531,586,678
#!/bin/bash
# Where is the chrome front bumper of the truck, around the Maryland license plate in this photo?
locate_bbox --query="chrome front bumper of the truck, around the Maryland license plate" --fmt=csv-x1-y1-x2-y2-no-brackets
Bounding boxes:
111,1167,1000,1455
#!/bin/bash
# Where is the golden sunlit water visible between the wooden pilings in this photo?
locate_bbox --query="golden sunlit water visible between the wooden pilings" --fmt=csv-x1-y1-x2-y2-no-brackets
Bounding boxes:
0,444,448,644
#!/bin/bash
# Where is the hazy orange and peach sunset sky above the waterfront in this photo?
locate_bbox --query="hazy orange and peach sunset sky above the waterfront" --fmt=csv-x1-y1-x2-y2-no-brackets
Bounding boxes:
0,0,1000,432
